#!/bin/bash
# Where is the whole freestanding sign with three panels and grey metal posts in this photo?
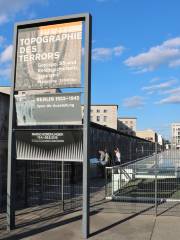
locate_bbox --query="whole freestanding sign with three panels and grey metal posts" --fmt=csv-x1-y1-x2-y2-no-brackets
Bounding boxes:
7,14,92,238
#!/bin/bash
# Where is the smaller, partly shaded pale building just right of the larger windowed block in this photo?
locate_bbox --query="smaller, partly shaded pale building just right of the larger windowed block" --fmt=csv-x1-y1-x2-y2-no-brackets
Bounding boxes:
117,117,137,136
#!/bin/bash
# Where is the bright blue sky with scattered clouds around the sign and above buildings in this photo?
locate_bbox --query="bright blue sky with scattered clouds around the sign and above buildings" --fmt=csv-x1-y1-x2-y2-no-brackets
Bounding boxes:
0,0,180,137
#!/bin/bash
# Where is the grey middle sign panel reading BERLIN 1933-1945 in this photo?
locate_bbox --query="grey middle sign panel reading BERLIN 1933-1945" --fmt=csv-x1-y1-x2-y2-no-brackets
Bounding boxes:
15,93,82,126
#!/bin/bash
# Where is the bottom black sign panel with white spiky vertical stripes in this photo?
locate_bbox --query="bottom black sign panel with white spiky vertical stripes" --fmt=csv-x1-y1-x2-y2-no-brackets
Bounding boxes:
15,130,83,162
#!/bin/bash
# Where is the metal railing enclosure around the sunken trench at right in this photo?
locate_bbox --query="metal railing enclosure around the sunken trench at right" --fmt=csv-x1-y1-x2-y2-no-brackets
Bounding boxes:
105,150,180,215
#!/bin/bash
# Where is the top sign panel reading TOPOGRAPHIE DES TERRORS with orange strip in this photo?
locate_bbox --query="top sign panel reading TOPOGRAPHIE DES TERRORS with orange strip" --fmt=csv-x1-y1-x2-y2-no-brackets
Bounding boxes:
15,22,82,90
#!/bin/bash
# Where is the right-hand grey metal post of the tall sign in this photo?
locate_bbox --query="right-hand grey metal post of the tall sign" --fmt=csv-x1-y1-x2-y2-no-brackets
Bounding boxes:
82,15,92,239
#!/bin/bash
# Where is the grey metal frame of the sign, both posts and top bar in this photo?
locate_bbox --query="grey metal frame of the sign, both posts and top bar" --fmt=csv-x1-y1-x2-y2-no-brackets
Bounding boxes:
7,13,92,238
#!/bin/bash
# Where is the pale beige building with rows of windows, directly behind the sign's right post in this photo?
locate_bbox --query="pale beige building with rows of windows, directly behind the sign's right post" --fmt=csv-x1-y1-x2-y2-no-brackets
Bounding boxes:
81,104,118,130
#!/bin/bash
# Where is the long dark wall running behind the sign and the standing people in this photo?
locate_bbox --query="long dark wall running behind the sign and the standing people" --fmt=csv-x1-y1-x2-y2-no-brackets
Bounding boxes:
1,123,154,214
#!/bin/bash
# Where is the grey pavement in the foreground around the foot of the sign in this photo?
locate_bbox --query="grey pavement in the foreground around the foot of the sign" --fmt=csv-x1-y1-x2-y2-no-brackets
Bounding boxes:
1,212,180,240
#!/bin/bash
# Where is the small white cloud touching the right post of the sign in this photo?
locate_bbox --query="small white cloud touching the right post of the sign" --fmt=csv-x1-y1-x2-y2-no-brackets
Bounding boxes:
92,46,125,61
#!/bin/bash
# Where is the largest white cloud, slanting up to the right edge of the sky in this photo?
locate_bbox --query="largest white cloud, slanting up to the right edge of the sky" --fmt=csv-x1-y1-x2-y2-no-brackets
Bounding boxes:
124,37,180,73
